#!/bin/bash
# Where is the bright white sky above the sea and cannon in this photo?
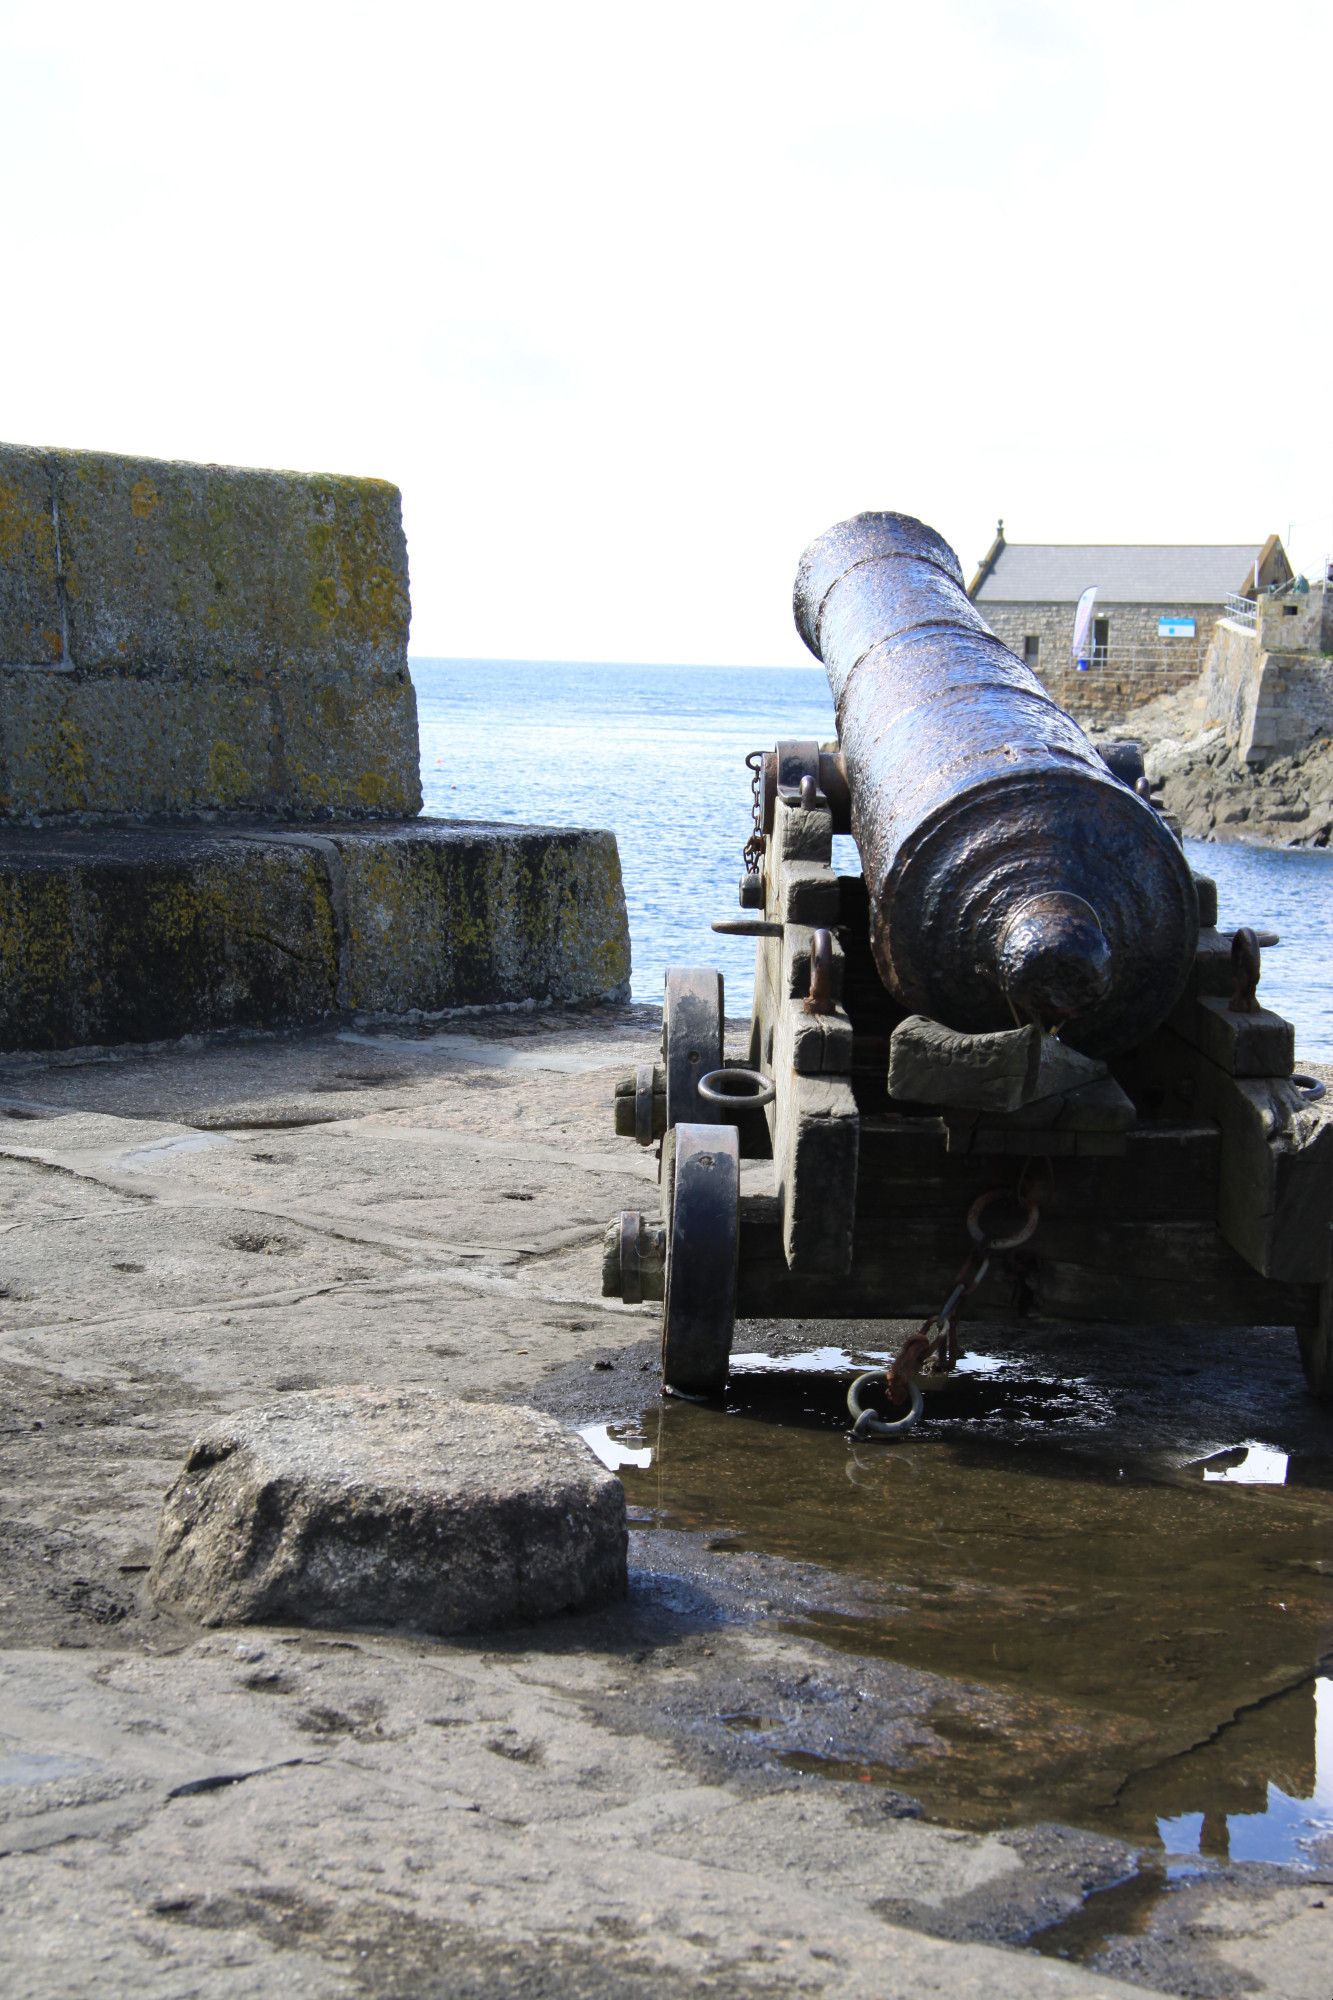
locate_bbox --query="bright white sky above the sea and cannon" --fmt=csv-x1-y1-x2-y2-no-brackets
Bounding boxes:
0,0,1333,664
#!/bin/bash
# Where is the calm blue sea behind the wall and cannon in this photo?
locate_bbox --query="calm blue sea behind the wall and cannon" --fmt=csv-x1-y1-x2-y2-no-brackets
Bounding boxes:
412,660,1333,1062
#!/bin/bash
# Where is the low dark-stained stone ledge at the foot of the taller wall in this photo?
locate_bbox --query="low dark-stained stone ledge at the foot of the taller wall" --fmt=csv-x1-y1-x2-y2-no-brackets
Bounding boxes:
0,820,630,1052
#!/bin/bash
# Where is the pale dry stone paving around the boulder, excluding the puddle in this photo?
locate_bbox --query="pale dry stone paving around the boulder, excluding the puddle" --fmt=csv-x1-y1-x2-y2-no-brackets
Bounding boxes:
0,1008,1327,2000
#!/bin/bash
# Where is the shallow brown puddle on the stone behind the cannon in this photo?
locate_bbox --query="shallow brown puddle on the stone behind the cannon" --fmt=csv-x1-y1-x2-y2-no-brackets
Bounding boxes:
598,1348,1333,1864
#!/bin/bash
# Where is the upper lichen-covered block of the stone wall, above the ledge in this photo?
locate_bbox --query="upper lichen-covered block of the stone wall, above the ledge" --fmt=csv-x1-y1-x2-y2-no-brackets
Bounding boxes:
0,444,420,822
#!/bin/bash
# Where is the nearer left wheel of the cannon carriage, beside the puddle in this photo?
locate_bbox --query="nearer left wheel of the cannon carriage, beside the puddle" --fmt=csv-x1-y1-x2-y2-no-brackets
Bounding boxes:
662,1124,741,1396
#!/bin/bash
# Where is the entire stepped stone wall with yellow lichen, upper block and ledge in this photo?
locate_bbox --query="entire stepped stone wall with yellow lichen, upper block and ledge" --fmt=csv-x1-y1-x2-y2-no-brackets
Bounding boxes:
0,444,630,1052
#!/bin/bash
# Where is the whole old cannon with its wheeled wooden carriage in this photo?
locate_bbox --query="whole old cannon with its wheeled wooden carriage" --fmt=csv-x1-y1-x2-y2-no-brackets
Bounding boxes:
602,514,1333,1436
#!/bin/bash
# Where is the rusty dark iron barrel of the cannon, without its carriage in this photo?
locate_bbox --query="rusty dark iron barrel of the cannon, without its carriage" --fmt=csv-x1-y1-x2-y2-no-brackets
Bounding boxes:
795,514,1199,1056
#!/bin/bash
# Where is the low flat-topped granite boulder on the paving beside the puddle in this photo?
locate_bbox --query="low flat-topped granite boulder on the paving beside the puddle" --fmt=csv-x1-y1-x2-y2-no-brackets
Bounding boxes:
148,1388,626,1632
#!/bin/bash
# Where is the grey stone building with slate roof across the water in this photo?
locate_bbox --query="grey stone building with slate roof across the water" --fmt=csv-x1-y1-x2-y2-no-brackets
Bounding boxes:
967,522,1291,724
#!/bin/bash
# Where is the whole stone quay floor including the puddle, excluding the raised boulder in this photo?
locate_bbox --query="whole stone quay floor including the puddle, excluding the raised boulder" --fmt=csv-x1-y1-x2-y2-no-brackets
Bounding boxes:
0,1008,1333,2000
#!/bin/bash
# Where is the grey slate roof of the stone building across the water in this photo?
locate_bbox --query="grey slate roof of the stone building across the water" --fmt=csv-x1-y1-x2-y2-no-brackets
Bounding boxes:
977,542,1261,604
